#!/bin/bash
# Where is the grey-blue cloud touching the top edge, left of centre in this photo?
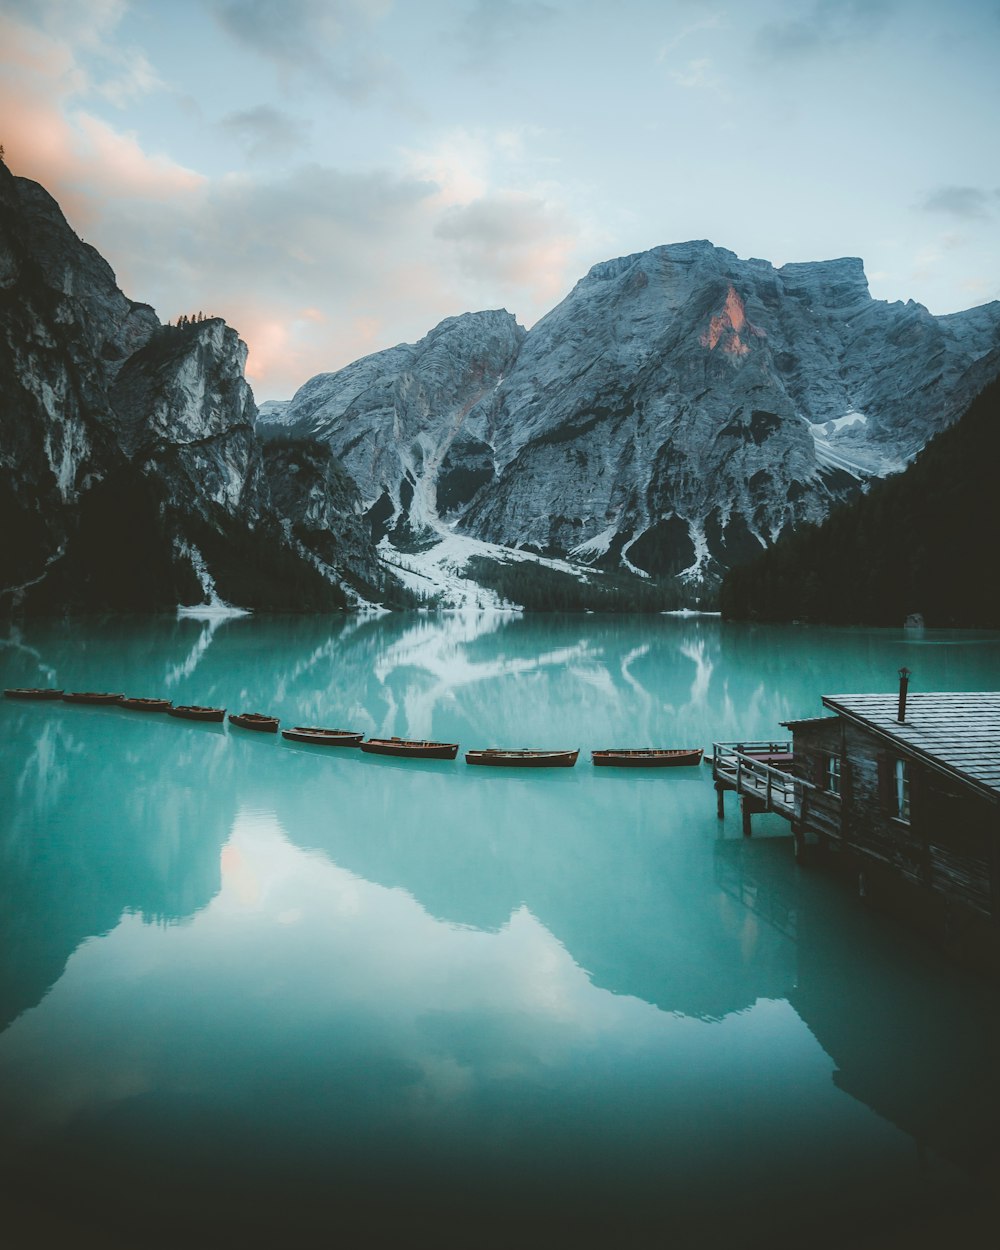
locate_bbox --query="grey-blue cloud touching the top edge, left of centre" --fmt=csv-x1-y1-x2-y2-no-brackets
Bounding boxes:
211,0,394,103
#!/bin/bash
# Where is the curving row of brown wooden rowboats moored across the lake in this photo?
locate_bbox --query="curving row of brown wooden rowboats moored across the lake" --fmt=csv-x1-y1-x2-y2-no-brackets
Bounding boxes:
4,688,703,769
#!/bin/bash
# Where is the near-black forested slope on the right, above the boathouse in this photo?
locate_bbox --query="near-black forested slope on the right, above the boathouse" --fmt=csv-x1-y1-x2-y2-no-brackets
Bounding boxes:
721,370,1000,629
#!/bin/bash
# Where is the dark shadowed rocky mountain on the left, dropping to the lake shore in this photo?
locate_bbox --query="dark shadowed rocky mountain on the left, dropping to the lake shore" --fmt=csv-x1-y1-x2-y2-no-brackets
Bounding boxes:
0,163,385,611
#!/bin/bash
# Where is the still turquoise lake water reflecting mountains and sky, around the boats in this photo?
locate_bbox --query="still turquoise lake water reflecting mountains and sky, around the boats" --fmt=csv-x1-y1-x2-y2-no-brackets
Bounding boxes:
0,615,1000,1248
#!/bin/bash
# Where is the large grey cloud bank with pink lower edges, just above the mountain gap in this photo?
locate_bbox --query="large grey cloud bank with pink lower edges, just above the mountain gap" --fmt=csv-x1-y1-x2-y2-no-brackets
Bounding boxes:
172,157,580,390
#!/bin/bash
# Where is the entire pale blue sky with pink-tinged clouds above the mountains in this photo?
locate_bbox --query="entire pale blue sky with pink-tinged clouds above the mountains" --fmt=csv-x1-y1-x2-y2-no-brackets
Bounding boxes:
0,0,1000,403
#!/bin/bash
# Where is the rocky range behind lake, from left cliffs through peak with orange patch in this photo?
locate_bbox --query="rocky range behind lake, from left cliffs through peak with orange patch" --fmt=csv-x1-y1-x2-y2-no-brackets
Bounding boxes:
7,160,1000,614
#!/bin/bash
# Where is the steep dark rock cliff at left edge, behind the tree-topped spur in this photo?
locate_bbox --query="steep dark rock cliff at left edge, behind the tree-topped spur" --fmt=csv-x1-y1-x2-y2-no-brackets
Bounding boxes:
0,166,158,600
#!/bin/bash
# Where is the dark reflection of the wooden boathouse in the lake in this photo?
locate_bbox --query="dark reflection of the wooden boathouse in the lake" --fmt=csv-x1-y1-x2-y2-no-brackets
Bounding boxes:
715,838,1000,1171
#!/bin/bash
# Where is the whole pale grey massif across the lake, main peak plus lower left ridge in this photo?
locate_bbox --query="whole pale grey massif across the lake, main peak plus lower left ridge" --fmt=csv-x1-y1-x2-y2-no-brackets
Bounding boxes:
261,241,1000,600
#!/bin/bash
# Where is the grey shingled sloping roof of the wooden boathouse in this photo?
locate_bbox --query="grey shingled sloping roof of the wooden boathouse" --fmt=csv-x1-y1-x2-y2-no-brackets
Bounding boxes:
823,690,1000,803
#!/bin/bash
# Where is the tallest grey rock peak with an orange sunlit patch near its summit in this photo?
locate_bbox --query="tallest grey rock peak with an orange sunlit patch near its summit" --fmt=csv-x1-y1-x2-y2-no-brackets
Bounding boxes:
461,243,1000,575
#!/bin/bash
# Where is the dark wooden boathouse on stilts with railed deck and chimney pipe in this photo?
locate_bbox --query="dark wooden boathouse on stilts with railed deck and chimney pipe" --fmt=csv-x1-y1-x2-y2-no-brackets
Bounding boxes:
713,685,1000,968
